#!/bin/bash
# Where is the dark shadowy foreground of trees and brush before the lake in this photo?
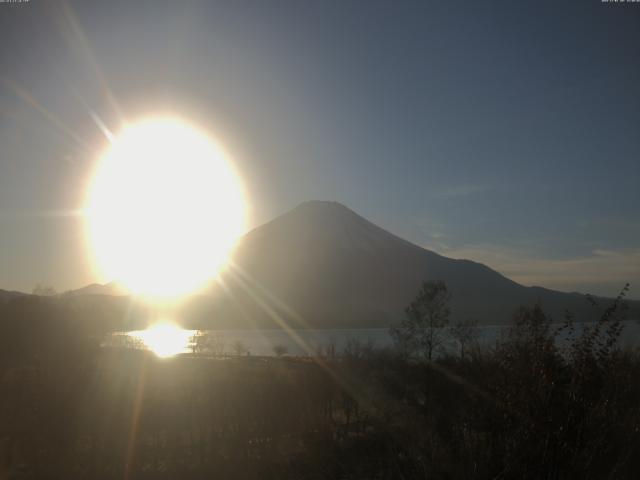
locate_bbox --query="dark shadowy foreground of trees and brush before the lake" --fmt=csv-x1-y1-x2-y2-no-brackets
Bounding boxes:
0,286,640,479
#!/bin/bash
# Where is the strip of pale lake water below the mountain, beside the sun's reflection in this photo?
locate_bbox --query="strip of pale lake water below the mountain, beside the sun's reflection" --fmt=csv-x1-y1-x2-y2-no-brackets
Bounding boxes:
105,320,640,356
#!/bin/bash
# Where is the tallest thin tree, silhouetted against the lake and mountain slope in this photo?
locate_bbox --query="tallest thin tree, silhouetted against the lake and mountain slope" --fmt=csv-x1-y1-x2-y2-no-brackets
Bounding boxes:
389,281,451,360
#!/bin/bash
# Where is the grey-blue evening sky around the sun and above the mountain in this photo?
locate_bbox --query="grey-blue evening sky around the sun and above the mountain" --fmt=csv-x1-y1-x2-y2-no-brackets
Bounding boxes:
0,0,640,298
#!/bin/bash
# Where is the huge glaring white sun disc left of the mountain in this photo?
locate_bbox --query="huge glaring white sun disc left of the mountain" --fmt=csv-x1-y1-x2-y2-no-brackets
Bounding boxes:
85,118,245,299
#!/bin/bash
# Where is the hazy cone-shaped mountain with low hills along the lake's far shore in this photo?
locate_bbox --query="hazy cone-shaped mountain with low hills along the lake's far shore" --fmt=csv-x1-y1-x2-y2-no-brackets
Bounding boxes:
17,201,640,328
